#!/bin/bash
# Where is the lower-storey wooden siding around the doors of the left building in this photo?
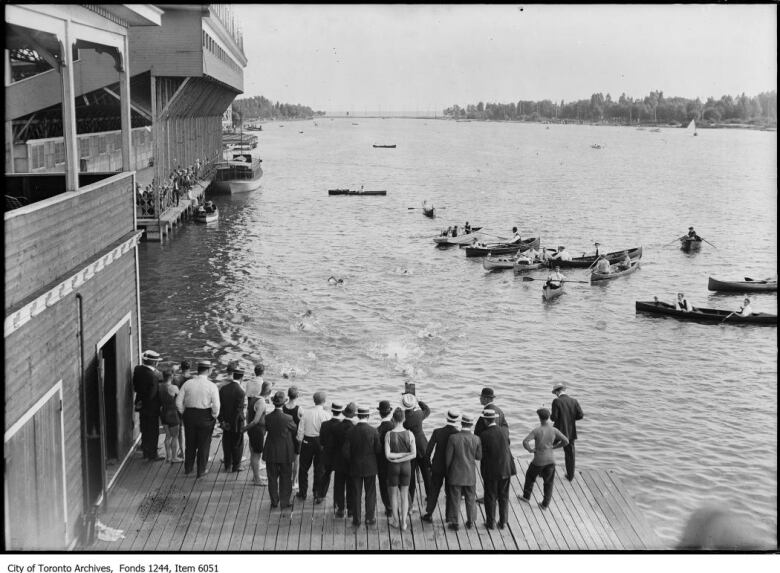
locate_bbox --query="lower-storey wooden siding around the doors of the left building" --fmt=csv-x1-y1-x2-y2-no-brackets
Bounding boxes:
5,250,138,548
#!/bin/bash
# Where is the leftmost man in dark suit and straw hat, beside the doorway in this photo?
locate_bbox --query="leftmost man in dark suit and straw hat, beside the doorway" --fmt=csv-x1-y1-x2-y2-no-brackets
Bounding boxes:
133,350,164,462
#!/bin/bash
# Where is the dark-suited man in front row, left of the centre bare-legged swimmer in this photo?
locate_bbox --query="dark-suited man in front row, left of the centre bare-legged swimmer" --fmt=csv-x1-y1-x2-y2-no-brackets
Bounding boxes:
342,407,382,527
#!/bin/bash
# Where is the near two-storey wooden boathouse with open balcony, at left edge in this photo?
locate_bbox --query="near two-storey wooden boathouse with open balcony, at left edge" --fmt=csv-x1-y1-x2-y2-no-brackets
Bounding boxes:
3,4,162,550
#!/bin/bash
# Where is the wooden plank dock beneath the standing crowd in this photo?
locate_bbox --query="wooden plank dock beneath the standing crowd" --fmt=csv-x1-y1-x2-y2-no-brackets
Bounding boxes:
90,436,671,553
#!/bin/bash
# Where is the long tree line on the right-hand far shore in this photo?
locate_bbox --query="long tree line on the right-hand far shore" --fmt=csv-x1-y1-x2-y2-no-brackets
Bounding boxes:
444,91,777,125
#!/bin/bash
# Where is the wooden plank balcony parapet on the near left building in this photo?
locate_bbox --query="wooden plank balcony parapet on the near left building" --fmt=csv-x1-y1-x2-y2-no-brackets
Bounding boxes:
5,173,135,315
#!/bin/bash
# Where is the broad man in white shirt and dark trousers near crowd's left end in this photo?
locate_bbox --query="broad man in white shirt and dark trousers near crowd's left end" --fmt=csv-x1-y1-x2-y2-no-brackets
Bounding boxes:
176,360,220,478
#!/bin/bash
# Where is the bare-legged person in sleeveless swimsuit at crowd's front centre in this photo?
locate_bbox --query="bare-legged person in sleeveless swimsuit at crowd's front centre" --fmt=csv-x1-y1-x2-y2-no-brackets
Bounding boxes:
384,408,417,531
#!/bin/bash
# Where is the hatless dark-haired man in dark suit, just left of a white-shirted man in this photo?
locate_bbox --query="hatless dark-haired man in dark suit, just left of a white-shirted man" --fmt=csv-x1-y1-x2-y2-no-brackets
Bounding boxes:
263,390,298,515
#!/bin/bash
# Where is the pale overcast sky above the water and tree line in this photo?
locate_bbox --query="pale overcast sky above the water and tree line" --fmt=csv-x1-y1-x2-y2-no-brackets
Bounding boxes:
234,4,777,111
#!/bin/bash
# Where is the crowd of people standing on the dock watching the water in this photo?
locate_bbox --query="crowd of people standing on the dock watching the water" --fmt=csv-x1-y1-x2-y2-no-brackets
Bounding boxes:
133,350,583,530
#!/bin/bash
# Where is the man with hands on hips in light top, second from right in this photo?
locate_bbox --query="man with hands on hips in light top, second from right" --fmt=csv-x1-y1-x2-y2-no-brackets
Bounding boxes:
518,408,569,509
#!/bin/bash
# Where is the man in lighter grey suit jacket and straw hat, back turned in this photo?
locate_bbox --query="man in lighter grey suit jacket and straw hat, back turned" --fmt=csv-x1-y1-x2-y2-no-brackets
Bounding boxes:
444,414,482,531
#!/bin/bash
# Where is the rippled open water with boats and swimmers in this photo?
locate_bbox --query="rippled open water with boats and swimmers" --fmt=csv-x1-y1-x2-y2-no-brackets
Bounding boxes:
141,118,777,544
